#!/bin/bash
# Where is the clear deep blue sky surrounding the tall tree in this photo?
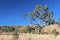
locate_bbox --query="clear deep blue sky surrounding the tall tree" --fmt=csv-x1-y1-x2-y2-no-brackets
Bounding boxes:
0,0,60,26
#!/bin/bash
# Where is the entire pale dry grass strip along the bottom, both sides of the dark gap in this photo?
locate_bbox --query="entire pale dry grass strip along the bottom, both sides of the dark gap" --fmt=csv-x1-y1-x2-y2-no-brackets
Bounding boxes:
0,33,60,40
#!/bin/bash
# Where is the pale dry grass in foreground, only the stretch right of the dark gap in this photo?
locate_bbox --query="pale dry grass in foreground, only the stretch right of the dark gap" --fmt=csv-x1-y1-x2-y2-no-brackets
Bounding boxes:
19,34,60,40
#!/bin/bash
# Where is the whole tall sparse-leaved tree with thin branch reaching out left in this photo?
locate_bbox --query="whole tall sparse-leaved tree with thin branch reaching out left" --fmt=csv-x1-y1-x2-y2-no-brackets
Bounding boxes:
24,5,55,34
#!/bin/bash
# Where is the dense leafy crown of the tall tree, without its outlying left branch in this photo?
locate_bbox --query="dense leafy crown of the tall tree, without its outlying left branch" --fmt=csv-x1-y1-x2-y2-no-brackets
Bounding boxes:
30,5,54,25
